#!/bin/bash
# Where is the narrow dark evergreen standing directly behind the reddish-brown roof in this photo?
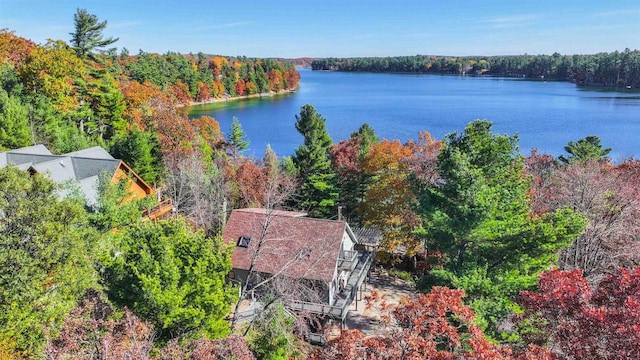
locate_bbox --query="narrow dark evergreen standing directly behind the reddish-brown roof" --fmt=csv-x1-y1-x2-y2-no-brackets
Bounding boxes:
293,104,338,218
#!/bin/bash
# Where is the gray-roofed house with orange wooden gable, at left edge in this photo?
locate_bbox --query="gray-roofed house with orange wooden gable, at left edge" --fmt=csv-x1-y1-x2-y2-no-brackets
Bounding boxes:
0,144,173,218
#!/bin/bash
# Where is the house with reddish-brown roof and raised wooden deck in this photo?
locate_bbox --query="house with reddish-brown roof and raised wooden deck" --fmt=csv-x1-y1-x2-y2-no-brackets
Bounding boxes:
223,208,375,323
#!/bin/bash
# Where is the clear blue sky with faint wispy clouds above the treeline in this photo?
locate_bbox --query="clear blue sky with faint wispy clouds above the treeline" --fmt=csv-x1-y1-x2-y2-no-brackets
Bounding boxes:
0,0,640,58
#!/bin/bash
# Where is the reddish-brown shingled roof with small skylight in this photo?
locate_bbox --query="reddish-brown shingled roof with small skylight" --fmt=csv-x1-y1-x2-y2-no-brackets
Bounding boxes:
222,208,347,282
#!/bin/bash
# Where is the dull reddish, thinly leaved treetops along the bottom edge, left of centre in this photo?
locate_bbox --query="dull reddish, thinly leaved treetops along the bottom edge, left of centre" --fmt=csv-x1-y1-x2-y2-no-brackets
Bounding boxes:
47,290,255,360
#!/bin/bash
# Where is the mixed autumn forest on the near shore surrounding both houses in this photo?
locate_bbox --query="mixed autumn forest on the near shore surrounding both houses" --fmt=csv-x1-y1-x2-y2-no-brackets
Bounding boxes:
0,9,640,359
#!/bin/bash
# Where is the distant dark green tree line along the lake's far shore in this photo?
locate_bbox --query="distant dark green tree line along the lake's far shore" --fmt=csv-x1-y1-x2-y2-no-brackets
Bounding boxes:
311,49,640,88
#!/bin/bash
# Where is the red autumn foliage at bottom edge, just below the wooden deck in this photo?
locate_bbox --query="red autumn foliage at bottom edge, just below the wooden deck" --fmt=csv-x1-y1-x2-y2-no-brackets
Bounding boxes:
313,287,551,360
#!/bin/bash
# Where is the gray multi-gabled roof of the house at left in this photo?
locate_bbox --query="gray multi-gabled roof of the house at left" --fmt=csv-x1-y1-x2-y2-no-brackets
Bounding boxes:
0,145,120,205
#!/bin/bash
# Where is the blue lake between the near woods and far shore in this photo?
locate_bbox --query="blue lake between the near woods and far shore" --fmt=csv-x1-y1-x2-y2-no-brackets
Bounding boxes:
189,70,640,161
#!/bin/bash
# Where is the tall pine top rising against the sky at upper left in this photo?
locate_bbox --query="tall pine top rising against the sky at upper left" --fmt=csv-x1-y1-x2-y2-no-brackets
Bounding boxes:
69,8,118,58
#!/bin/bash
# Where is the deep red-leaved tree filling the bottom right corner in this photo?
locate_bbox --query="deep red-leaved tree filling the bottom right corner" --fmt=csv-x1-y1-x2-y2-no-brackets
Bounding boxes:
521,267,640,359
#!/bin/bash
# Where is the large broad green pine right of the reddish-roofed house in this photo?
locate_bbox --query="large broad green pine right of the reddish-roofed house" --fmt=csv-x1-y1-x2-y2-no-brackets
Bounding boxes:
418,120,584,336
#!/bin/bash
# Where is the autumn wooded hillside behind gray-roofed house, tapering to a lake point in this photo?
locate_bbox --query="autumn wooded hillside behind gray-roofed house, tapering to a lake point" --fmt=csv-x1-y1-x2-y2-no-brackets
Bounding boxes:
0,26,300,152
